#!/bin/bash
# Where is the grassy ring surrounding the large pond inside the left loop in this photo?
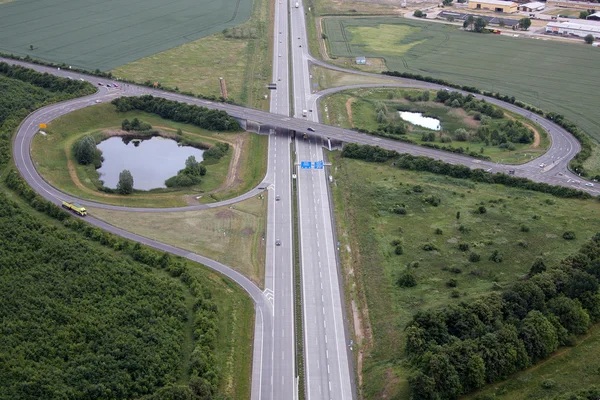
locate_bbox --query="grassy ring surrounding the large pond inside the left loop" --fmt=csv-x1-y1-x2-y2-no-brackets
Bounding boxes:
32,104,267,207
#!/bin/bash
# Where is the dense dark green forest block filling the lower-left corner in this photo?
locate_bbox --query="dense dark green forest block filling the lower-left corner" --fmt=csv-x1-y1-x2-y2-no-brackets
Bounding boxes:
0,192,187,399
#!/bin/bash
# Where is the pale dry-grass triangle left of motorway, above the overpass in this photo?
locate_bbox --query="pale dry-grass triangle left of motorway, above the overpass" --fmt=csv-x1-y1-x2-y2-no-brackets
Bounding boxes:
112,0,271,109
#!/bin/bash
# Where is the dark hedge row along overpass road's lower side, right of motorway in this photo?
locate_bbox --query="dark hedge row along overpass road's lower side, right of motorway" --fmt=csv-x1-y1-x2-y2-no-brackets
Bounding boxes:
342,143,592,199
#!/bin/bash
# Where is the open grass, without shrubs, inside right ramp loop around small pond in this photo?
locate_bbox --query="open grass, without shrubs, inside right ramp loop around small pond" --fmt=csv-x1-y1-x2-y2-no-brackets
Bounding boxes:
321,88,550,164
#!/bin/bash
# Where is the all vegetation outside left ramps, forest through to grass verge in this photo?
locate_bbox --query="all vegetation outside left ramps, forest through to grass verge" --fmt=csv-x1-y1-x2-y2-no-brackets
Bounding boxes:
0,64,253,400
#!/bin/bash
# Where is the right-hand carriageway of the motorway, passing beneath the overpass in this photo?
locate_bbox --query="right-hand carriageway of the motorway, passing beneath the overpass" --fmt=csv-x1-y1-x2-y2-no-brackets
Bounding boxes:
290,2,355,400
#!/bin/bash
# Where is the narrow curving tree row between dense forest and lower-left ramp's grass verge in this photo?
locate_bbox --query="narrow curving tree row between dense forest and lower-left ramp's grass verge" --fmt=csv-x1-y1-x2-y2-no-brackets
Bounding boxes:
0,171,224,400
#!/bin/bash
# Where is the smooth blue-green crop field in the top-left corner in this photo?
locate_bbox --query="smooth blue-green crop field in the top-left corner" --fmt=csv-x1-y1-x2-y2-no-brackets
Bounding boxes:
0,0,252,71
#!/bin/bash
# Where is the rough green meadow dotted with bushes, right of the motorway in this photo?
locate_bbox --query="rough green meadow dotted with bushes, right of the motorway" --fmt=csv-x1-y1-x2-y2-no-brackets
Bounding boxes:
331,153,600,399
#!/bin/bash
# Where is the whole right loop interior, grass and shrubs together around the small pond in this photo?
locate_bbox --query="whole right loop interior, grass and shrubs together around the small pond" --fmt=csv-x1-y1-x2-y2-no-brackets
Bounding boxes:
321,88,550,163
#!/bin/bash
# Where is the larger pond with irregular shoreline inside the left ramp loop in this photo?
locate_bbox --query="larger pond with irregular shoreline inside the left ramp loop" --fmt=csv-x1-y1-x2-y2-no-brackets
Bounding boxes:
98,136,204,190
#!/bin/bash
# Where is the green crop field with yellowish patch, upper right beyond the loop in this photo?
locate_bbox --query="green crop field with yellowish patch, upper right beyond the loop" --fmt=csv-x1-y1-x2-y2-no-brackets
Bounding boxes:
324,18,600,171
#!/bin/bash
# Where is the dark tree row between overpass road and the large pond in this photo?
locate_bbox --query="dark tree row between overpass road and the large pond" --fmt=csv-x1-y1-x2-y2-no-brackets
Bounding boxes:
112,95,240,131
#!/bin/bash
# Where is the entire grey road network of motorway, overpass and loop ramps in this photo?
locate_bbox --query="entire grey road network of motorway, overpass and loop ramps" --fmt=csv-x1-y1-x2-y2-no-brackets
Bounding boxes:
0,19,600,399
